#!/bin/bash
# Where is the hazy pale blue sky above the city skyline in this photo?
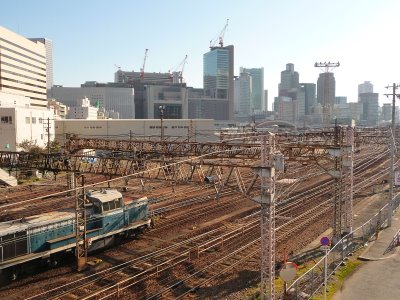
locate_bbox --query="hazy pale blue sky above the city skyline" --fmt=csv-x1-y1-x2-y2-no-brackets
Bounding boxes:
0,0,400,107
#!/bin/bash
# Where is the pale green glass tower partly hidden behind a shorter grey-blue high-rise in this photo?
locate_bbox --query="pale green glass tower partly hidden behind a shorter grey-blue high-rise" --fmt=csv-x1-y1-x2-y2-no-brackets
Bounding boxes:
240,67,267,111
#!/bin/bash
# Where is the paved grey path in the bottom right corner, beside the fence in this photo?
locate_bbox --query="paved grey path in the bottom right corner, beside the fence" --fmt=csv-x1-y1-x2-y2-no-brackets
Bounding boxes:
332,209,400,300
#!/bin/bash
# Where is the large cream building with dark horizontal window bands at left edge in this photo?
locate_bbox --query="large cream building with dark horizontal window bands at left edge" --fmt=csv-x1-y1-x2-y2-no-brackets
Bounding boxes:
0,27,47,108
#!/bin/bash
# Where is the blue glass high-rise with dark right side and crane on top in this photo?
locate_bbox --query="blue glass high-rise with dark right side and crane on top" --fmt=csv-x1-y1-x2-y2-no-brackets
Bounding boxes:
203,45,234,120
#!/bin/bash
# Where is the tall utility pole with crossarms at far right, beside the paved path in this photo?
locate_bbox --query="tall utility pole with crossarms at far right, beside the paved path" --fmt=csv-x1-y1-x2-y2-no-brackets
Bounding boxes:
385,83,400,227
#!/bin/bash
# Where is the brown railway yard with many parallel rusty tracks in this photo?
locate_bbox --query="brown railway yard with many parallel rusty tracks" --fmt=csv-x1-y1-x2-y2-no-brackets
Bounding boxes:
0,128,390,299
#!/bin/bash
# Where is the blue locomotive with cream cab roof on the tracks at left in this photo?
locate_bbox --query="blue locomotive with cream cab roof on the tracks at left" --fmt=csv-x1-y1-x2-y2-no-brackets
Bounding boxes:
0,189,151,280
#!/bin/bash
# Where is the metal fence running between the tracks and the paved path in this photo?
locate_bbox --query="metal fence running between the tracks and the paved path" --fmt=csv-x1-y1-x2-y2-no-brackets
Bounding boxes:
280,193,400,300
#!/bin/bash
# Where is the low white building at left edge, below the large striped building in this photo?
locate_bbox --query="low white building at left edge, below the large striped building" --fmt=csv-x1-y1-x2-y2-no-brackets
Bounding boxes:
0,92,54,151
